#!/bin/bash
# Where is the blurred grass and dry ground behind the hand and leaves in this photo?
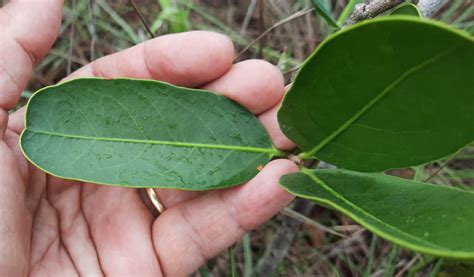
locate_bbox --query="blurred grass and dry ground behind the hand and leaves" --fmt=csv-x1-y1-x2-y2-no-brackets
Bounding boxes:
19,0,474,276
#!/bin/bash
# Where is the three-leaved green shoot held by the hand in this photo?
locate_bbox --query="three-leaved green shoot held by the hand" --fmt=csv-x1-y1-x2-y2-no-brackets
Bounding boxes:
20,16,474,259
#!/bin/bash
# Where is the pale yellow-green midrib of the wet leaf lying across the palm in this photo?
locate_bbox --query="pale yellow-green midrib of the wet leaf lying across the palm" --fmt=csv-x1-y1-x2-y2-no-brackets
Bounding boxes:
25,128,280,156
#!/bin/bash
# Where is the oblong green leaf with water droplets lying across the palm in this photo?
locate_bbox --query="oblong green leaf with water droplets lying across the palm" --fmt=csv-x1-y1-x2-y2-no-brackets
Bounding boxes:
21,78,279,190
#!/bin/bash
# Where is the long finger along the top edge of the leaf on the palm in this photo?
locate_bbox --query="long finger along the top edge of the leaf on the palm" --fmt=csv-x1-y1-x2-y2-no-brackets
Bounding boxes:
67,31,234,87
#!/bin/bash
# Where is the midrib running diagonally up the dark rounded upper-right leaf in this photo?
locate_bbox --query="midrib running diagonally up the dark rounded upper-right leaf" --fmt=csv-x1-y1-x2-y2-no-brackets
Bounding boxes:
301,48,455,159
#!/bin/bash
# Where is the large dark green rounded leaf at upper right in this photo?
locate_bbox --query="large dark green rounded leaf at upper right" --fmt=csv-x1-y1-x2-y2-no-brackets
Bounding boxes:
278,16,474,172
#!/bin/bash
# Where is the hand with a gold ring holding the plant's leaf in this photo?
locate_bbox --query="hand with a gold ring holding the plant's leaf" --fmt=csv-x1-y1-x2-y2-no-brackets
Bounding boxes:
0,0,297,276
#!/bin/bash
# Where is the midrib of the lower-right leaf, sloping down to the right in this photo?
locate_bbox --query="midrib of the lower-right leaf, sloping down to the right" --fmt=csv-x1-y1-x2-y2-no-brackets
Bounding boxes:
301,169,448,250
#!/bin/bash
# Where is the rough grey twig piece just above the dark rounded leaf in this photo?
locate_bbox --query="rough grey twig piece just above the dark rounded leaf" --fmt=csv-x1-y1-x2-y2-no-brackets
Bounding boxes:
344,0,404,27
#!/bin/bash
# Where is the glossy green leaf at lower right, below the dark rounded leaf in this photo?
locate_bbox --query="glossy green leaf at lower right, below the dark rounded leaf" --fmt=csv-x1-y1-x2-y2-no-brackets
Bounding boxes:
280,169,474,259
